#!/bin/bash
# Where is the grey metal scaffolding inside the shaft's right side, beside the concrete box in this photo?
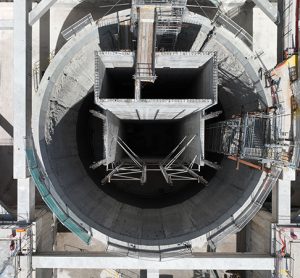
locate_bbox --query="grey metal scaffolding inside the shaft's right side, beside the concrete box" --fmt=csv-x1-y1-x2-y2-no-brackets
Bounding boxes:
206,113,293,167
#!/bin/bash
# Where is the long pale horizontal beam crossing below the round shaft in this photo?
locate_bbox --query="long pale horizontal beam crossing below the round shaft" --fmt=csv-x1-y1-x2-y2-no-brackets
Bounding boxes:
29,252,274,271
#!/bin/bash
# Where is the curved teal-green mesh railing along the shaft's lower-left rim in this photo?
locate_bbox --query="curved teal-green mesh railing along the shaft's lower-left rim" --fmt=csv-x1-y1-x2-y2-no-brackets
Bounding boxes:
26,143,91,244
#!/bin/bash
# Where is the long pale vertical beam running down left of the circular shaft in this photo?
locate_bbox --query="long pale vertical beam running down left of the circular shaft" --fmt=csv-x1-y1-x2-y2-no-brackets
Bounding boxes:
13,0,35,222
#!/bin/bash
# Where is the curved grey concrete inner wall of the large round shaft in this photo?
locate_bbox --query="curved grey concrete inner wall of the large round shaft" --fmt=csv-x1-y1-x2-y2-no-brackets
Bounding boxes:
33,9,270,245
